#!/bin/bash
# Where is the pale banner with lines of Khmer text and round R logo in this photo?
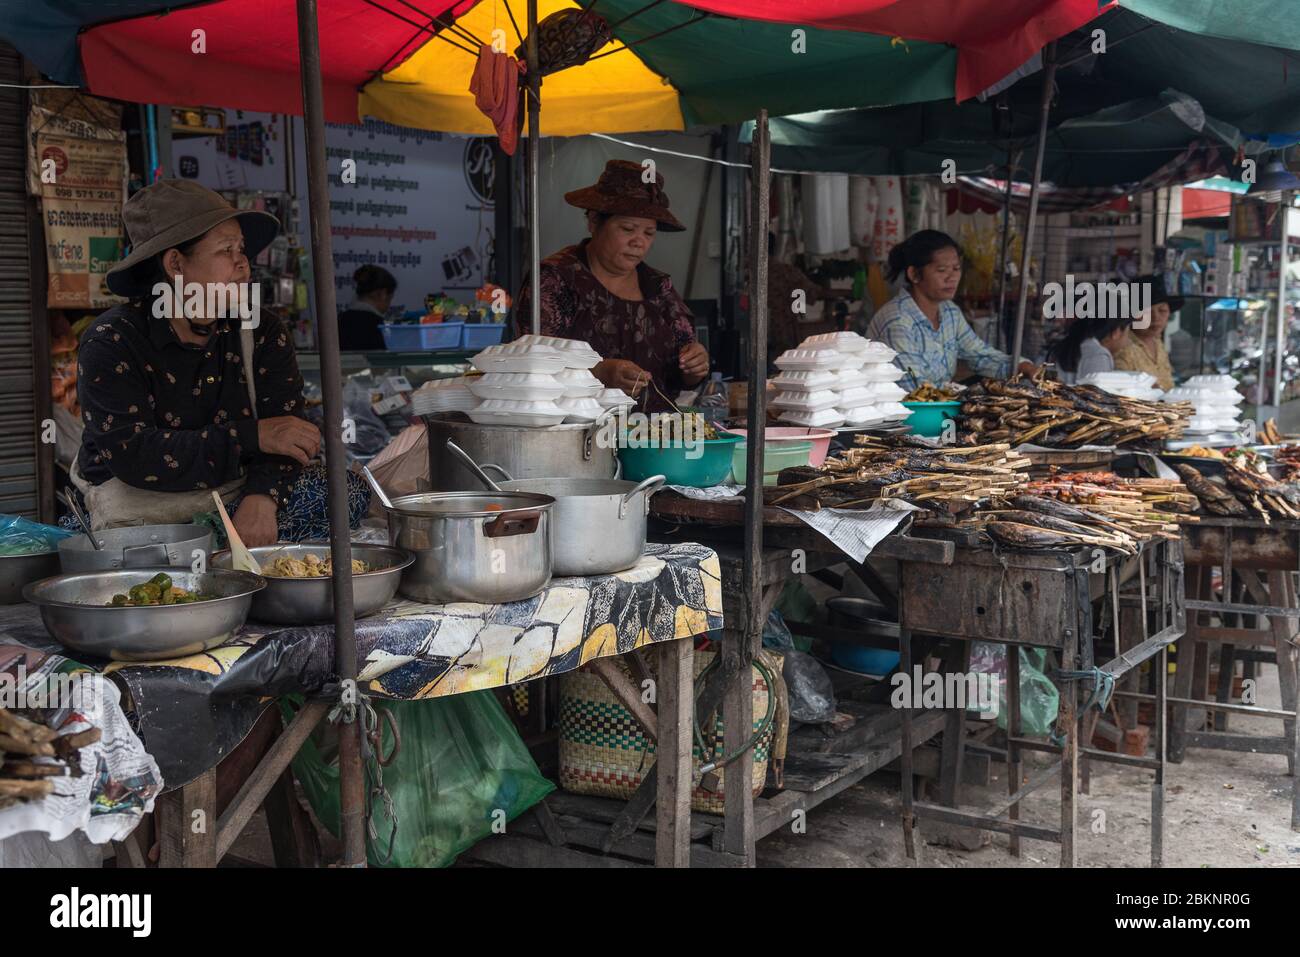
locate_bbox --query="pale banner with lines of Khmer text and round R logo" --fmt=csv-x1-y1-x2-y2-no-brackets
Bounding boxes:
295,120,495,316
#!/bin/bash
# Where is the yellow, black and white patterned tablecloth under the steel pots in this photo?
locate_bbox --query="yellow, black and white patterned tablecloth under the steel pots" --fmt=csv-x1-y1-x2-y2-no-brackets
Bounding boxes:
0,544,723,788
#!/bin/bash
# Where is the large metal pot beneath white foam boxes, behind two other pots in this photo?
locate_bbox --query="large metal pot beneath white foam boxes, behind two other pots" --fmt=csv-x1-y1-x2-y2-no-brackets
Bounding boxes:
424,412,619,492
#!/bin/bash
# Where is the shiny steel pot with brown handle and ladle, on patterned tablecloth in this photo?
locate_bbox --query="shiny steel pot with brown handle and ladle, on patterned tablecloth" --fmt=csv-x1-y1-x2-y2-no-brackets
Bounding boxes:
386,492,555,603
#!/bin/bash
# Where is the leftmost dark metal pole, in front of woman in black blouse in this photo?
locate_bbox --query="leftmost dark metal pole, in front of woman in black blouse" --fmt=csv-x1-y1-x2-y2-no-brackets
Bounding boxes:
298,0,365,867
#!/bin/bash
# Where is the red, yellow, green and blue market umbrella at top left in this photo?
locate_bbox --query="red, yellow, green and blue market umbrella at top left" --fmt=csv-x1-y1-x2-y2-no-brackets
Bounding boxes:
0,0,957,135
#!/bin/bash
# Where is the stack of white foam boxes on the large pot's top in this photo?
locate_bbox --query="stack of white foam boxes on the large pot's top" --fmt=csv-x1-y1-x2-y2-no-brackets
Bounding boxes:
465,335,616,426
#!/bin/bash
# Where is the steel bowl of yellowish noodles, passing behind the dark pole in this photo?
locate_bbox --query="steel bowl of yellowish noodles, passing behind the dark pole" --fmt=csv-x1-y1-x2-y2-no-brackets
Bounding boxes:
212,542,415,624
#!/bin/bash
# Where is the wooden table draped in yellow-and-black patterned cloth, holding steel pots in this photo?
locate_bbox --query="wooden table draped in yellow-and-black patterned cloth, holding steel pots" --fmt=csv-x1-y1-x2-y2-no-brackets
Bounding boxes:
0,544,723,867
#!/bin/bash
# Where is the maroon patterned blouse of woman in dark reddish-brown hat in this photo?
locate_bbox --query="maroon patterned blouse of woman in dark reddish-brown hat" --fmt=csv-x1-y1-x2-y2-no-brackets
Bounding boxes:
515,239,696,412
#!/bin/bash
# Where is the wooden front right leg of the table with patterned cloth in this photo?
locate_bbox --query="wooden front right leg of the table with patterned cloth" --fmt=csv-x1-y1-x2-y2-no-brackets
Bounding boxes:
654,638,696,867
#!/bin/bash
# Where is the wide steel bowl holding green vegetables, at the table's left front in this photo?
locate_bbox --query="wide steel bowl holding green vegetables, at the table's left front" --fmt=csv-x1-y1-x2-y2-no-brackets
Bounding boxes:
22,564,267,662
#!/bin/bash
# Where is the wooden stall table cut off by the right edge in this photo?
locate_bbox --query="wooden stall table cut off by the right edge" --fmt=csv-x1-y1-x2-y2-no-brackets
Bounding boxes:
1169,516,1300,831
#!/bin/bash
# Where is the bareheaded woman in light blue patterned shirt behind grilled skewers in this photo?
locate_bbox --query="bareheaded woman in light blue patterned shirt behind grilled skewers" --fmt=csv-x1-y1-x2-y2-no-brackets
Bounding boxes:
867,229,1035,389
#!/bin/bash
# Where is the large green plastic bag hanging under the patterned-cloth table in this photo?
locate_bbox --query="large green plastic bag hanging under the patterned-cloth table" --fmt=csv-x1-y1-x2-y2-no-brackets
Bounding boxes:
280,692,555,867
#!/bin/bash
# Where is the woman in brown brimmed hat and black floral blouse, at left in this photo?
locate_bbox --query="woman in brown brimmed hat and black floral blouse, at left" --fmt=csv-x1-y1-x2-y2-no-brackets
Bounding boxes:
72,179,369,547
